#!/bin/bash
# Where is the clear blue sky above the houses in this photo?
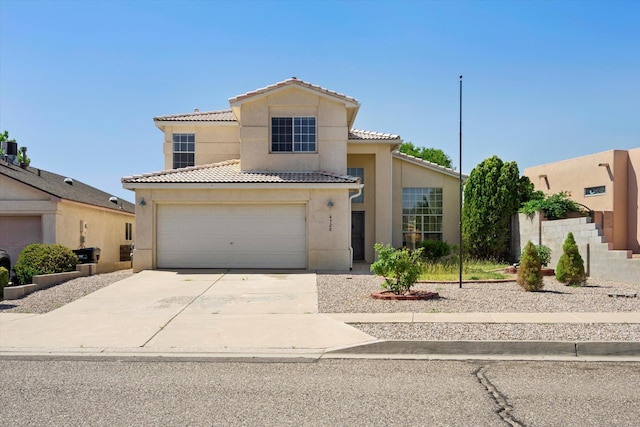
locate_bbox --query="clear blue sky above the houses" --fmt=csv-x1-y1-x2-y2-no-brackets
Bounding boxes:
0,0,640,200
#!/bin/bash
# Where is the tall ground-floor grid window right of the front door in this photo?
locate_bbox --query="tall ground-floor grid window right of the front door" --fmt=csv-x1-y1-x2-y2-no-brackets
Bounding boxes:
402,187,443,249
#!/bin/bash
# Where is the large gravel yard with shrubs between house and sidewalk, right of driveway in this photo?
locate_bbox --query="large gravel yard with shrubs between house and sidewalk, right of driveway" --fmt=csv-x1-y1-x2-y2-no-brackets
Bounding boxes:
318,274,640,313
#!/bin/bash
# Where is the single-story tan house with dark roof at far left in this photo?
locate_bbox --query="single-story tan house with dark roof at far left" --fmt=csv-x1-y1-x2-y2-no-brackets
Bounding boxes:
0,160,135,272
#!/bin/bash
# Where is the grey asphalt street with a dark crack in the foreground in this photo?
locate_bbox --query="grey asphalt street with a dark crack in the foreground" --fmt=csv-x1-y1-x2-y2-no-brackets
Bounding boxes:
0,358,640,426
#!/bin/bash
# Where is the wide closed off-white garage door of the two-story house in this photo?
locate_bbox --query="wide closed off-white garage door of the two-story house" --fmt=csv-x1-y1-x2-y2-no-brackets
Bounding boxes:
156,205,307,268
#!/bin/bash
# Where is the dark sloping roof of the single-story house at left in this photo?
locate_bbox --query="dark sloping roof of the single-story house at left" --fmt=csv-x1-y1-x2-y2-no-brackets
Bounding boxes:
0,160,135,213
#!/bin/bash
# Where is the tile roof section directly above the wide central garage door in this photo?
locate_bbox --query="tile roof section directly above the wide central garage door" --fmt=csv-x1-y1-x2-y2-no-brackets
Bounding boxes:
122,160,359,184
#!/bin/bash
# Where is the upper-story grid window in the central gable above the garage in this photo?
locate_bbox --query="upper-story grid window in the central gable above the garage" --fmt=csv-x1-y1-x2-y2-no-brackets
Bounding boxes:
271,117,316,153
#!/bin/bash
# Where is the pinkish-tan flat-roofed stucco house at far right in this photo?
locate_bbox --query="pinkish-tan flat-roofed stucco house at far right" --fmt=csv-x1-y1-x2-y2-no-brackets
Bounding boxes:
524,148,640,254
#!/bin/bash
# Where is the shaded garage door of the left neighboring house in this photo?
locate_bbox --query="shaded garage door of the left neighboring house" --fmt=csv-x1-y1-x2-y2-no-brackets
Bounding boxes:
0,216,42,265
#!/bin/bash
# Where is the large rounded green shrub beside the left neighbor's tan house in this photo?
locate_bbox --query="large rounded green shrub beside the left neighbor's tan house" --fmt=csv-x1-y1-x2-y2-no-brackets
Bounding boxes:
13,243,78,285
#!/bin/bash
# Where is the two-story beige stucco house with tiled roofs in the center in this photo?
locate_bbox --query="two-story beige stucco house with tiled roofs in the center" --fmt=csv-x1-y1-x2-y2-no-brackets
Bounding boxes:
122,78,464,271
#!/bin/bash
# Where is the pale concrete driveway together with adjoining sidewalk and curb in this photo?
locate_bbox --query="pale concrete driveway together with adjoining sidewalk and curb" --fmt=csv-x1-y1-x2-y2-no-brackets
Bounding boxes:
0,270,640,360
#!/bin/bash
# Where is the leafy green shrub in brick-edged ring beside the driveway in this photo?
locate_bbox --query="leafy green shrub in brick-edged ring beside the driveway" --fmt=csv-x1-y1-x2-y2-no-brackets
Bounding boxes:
371,243,422,295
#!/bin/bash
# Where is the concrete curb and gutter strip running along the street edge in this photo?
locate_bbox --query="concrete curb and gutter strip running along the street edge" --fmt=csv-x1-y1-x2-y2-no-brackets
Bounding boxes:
0,341,640,363
